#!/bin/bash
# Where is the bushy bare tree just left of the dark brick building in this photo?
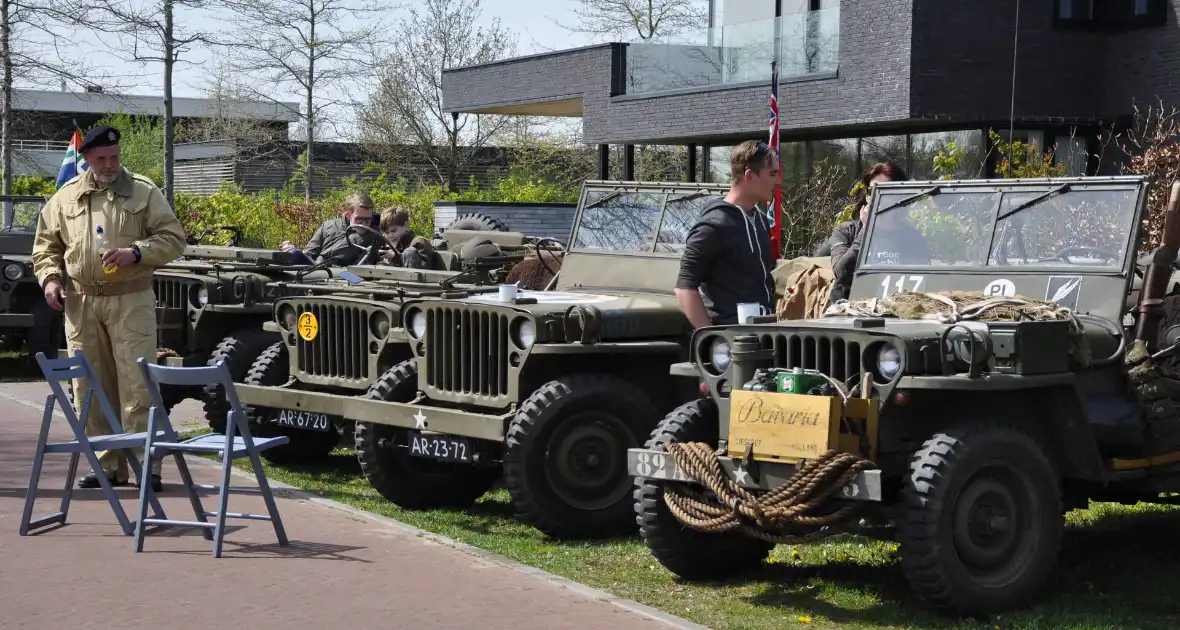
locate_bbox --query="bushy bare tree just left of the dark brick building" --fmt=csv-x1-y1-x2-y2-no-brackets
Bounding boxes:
358,0,516,190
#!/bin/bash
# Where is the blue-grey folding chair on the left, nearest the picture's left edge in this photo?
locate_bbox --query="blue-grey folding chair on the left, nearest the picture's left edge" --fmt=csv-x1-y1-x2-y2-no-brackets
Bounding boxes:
20,349,164,536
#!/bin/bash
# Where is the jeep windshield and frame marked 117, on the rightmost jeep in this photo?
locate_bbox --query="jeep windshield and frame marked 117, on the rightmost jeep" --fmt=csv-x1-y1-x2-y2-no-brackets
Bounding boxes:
848,176,1148,323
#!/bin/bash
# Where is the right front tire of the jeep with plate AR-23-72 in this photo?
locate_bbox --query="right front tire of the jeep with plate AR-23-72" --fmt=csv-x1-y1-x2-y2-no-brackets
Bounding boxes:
504,374,660,538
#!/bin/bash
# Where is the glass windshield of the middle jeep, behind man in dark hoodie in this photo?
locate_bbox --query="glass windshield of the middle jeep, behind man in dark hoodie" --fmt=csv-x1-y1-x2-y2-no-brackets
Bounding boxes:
570,184,721,255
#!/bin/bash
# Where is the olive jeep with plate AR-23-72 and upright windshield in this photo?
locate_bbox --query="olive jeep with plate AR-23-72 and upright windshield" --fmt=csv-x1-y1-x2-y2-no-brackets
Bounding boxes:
231,182,726,537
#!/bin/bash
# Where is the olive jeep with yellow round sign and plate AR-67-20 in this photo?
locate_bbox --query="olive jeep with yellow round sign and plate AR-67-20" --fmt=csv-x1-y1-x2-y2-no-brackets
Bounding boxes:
234,221,565,462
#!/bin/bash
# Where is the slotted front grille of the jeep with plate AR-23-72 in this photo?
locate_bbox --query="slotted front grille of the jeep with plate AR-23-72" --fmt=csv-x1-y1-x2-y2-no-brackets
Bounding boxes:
426,307,509,396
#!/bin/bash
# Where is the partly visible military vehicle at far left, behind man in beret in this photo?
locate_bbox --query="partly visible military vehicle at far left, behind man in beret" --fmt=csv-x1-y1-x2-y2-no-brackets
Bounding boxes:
0,195,65,357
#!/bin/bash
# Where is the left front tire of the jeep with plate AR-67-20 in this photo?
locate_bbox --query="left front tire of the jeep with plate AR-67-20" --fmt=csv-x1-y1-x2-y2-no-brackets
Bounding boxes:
245,341,340,465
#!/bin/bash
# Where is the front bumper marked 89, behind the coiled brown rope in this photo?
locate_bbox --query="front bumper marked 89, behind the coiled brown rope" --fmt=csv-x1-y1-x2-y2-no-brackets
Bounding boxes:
627,448,881,501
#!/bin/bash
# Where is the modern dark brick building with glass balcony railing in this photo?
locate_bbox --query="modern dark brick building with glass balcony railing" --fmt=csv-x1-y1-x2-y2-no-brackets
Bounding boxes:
443,0,1180,188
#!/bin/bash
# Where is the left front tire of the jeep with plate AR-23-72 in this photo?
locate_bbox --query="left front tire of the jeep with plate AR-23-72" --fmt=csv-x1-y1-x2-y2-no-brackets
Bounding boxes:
354,360,499,510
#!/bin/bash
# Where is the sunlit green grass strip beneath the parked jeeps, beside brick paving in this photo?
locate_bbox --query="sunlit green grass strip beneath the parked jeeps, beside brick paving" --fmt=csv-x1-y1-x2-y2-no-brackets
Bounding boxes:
171,424,1180,630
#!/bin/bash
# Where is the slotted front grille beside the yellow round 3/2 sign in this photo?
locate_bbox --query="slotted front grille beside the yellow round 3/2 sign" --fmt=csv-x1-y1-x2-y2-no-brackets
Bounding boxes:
293,302,369,379
